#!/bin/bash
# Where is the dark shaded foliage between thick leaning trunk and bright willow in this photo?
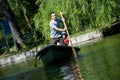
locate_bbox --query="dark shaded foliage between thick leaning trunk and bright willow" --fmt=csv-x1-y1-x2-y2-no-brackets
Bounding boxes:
5,0,38,45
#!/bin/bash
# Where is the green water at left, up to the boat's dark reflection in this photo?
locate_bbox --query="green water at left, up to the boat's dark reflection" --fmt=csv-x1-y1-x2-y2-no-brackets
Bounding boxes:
0,57,44,80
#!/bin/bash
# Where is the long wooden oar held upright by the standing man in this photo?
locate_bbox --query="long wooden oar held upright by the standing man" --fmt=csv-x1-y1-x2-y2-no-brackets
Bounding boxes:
60,11,82,80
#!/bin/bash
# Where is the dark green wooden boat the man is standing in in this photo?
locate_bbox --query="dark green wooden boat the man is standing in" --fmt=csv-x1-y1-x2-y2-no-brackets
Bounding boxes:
36,45,80,65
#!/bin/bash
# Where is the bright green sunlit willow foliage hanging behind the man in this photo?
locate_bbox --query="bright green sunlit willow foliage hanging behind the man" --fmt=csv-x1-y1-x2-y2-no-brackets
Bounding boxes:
34,0,120,40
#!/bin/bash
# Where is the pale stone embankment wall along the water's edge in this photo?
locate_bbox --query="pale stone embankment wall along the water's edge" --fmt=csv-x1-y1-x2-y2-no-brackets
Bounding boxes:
0,31,103,66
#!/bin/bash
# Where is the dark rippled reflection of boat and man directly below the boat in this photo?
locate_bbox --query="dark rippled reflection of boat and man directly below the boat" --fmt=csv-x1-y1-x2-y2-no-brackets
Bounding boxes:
41,61,79,80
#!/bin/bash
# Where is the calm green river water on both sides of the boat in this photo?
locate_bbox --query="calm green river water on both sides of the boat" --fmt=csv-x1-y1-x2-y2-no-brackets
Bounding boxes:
0,34,120,80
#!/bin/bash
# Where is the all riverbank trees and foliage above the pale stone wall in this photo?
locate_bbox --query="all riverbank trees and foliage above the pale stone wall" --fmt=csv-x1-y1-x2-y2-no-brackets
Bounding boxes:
0,0,120,54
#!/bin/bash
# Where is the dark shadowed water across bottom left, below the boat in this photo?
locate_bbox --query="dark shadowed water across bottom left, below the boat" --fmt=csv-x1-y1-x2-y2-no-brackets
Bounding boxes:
0,55,83,80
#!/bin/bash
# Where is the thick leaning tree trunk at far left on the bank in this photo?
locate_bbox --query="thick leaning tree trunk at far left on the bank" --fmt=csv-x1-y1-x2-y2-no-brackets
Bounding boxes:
0,0,25,50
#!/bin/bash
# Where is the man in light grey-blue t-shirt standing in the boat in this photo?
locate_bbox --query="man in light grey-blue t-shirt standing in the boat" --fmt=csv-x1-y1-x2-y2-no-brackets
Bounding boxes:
49,12,66,45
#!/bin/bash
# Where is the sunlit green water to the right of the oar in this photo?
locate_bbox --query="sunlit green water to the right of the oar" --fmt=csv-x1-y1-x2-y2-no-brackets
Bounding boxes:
80,34,120,80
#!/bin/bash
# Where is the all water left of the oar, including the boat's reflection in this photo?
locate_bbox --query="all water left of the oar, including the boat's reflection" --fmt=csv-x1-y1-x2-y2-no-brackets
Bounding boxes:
0,59,81,80
